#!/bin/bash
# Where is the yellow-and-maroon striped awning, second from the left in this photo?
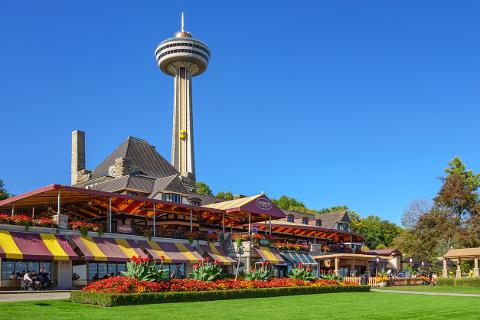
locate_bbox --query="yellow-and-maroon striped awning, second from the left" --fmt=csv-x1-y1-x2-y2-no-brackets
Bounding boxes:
72,236,146,262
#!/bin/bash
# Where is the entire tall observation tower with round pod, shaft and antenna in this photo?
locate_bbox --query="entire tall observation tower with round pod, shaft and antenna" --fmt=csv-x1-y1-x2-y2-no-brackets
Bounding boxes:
155,13,210,188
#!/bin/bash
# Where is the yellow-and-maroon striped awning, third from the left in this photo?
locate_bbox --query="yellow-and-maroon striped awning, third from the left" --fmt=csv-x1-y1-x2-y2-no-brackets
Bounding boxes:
139,240,203,263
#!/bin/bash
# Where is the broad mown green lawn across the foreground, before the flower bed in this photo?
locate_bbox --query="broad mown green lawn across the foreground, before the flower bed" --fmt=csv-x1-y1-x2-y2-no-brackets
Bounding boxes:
0,292,480,320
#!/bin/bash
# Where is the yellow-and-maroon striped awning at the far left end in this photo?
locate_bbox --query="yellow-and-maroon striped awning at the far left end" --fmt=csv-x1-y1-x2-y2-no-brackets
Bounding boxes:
0,230,78,260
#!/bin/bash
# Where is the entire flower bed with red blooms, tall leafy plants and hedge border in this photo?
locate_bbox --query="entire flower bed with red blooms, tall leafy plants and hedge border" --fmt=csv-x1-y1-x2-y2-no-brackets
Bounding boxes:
71,257,370,306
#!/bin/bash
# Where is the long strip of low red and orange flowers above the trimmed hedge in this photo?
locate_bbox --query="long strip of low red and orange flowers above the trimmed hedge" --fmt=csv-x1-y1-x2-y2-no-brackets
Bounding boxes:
82,277,357,293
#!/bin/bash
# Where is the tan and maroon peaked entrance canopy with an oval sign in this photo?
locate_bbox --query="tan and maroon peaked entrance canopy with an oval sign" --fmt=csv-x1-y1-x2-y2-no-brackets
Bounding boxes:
203,194,285,219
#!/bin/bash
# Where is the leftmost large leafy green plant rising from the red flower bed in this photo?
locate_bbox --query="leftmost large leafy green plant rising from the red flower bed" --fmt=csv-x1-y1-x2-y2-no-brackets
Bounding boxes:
123,256,166,282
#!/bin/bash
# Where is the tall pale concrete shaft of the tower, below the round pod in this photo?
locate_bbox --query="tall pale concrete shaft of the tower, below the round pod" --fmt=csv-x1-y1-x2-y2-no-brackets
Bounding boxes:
172,64,195,184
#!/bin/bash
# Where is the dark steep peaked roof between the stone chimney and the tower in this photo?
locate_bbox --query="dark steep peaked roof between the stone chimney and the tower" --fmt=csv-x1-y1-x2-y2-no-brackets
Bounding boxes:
92,137,178,179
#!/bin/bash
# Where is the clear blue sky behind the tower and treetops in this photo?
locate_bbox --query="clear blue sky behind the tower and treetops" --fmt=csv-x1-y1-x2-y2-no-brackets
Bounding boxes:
0,0,480,222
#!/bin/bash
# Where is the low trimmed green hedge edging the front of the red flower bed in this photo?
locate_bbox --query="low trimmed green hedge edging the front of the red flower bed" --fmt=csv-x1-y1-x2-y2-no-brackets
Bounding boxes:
71,286,370,307
